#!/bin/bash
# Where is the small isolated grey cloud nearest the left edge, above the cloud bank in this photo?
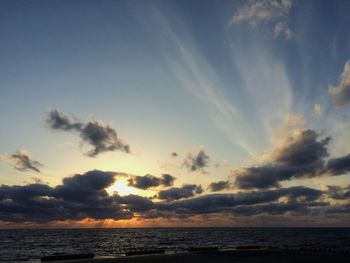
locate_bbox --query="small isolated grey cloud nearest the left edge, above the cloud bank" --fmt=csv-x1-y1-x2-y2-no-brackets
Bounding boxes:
5,150,43,173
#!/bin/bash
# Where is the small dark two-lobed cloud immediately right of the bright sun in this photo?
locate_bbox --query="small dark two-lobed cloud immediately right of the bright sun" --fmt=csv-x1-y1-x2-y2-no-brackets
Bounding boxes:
128,174,176,190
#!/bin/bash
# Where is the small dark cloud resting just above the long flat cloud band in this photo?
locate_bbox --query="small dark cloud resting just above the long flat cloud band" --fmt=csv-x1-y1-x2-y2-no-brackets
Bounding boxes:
158,184,203,201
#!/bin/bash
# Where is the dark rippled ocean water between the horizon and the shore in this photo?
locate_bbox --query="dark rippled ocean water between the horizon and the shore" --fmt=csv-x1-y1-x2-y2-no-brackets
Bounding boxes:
0,228,350,262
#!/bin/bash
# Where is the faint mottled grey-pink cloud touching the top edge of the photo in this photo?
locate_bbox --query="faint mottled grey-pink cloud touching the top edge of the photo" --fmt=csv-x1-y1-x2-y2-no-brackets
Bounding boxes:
231,0,294,39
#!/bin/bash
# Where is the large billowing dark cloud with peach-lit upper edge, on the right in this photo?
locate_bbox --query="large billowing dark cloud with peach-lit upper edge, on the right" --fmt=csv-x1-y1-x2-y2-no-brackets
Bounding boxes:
232,130,330,189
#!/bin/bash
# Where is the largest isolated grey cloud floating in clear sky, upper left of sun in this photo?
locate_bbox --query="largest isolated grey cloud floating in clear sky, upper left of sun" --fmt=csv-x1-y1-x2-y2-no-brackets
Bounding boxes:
46,109,130,157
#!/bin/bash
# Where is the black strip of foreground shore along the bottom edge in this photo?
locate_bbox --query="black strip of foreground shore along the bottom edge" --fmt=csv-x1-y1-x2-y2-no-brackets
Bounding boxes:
60,250,350,263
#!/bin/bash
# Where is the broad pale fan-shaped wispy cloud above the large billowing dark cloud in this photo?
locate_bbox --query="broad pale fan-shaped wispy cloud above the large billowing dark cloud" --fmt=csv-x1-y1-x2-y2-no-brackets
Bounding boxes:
232,48,294,146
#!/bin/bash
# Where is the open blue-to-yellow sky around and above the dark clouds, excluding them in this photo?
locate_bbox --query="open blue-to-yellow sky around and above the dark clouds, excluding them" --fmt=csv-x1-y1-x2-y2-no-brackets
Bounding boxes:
0,0,350,227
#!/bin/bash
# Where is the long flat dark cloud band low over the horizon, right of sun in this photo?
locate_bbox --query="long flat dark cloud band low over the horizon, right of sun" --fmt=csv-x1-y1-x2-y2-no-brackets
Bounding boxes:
157,186,323,216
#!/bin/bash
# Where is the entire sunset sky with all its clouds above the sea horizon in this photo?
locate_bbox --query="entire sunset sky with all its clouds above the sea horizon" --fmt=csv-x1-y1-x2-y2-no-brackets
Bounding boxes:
0,0,350,228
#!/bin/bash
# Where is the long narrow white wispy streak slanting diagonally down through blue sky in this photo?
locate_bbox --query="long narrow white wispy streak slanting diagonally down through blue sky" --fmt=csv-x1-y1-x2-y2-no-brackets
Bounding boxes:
159,18,256,159
